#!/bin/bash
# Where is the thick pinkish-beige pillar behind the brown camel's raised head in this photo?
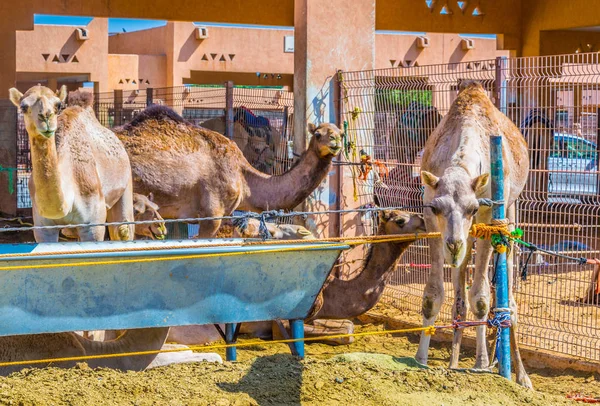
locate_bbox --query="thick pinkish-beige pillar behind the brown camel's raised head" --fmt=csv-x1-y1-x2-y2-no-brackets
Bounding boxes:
294,0,375,237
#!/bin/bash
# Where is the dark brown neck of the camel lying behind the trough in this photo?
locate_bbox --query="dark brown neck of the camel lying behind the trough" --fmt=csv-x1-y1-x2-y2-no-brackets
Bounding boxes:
313,241,414,319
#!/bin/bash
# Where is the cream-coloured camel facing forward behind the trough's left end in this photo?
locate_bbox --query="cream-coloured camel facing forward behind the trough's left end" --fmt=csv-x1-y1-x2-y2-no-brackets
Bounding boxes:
9,85,134,242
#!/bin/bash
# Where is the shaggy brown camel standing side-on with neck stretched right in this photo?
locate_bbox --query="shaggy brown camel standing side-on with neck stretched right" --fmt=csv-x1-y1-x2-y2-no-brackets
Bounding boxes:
108,106,342,238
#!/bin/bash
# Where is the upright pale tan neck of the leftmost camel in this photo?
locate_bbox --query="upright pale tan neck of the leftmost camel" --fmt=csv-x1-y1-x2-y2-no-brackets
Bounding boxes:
29,135,70,219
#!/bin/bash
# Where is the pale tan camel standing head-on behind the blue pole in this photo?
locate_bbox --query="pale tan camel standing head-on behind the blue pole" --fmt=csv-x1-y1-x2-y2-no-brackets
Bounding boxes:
416,81,531,388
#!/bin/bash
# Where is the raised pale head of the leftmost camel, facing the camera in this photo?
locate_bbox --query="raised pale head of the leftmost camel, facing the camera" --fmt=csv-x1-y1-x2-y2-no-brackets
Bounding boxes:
9,85,67,139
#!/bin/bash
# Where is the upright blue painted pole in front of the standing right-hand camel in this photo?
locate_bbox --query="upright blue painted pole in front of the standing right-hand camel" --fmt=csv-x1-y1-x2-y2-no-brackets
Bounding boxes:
490,135,511,380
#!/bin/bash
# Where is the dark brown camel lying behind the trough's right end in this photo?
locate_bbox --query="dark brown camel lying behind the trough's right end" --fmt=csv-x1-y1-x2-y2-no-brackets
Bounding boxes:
167,210,425,345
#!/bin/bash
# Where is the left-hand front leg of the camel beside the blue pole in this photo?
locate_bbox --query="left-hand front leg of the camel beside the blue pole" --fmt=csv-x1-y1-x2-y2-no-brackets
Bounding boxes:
415,232,444,364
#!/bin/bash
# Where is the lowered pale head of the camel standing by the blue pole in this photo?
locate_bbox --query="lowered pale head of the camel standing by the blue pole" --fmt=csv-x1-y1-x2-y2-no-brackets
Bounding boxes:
421,167,490,267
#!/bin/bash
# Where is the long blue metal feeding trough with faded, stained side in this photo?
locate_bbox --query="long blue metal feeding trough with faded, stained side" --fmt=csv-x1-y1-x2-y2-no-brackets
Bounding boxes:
0,240,348,336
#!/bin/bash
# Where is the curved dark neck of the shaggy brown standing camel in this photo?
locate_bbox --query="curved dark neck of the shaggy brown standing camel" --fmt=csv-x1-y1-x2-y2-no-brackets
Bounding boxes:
239,146,333,211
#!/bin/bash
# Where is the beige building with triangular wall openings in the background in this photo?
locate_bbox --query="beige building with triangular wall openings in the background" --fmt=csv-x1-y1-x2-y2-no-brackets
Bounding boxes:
15,18,508,92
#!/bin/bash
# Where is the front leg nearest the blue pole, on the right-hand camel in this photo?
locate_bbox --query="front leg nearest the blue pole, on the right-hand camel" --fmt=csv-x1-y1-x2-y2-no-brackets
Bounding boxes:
469,240,493,369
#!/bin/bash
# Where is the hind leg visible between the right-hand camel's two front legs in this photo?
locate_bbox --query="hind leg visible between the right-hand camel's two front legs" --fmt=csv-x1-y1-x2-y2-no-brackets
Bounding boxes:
450,238,473,368
